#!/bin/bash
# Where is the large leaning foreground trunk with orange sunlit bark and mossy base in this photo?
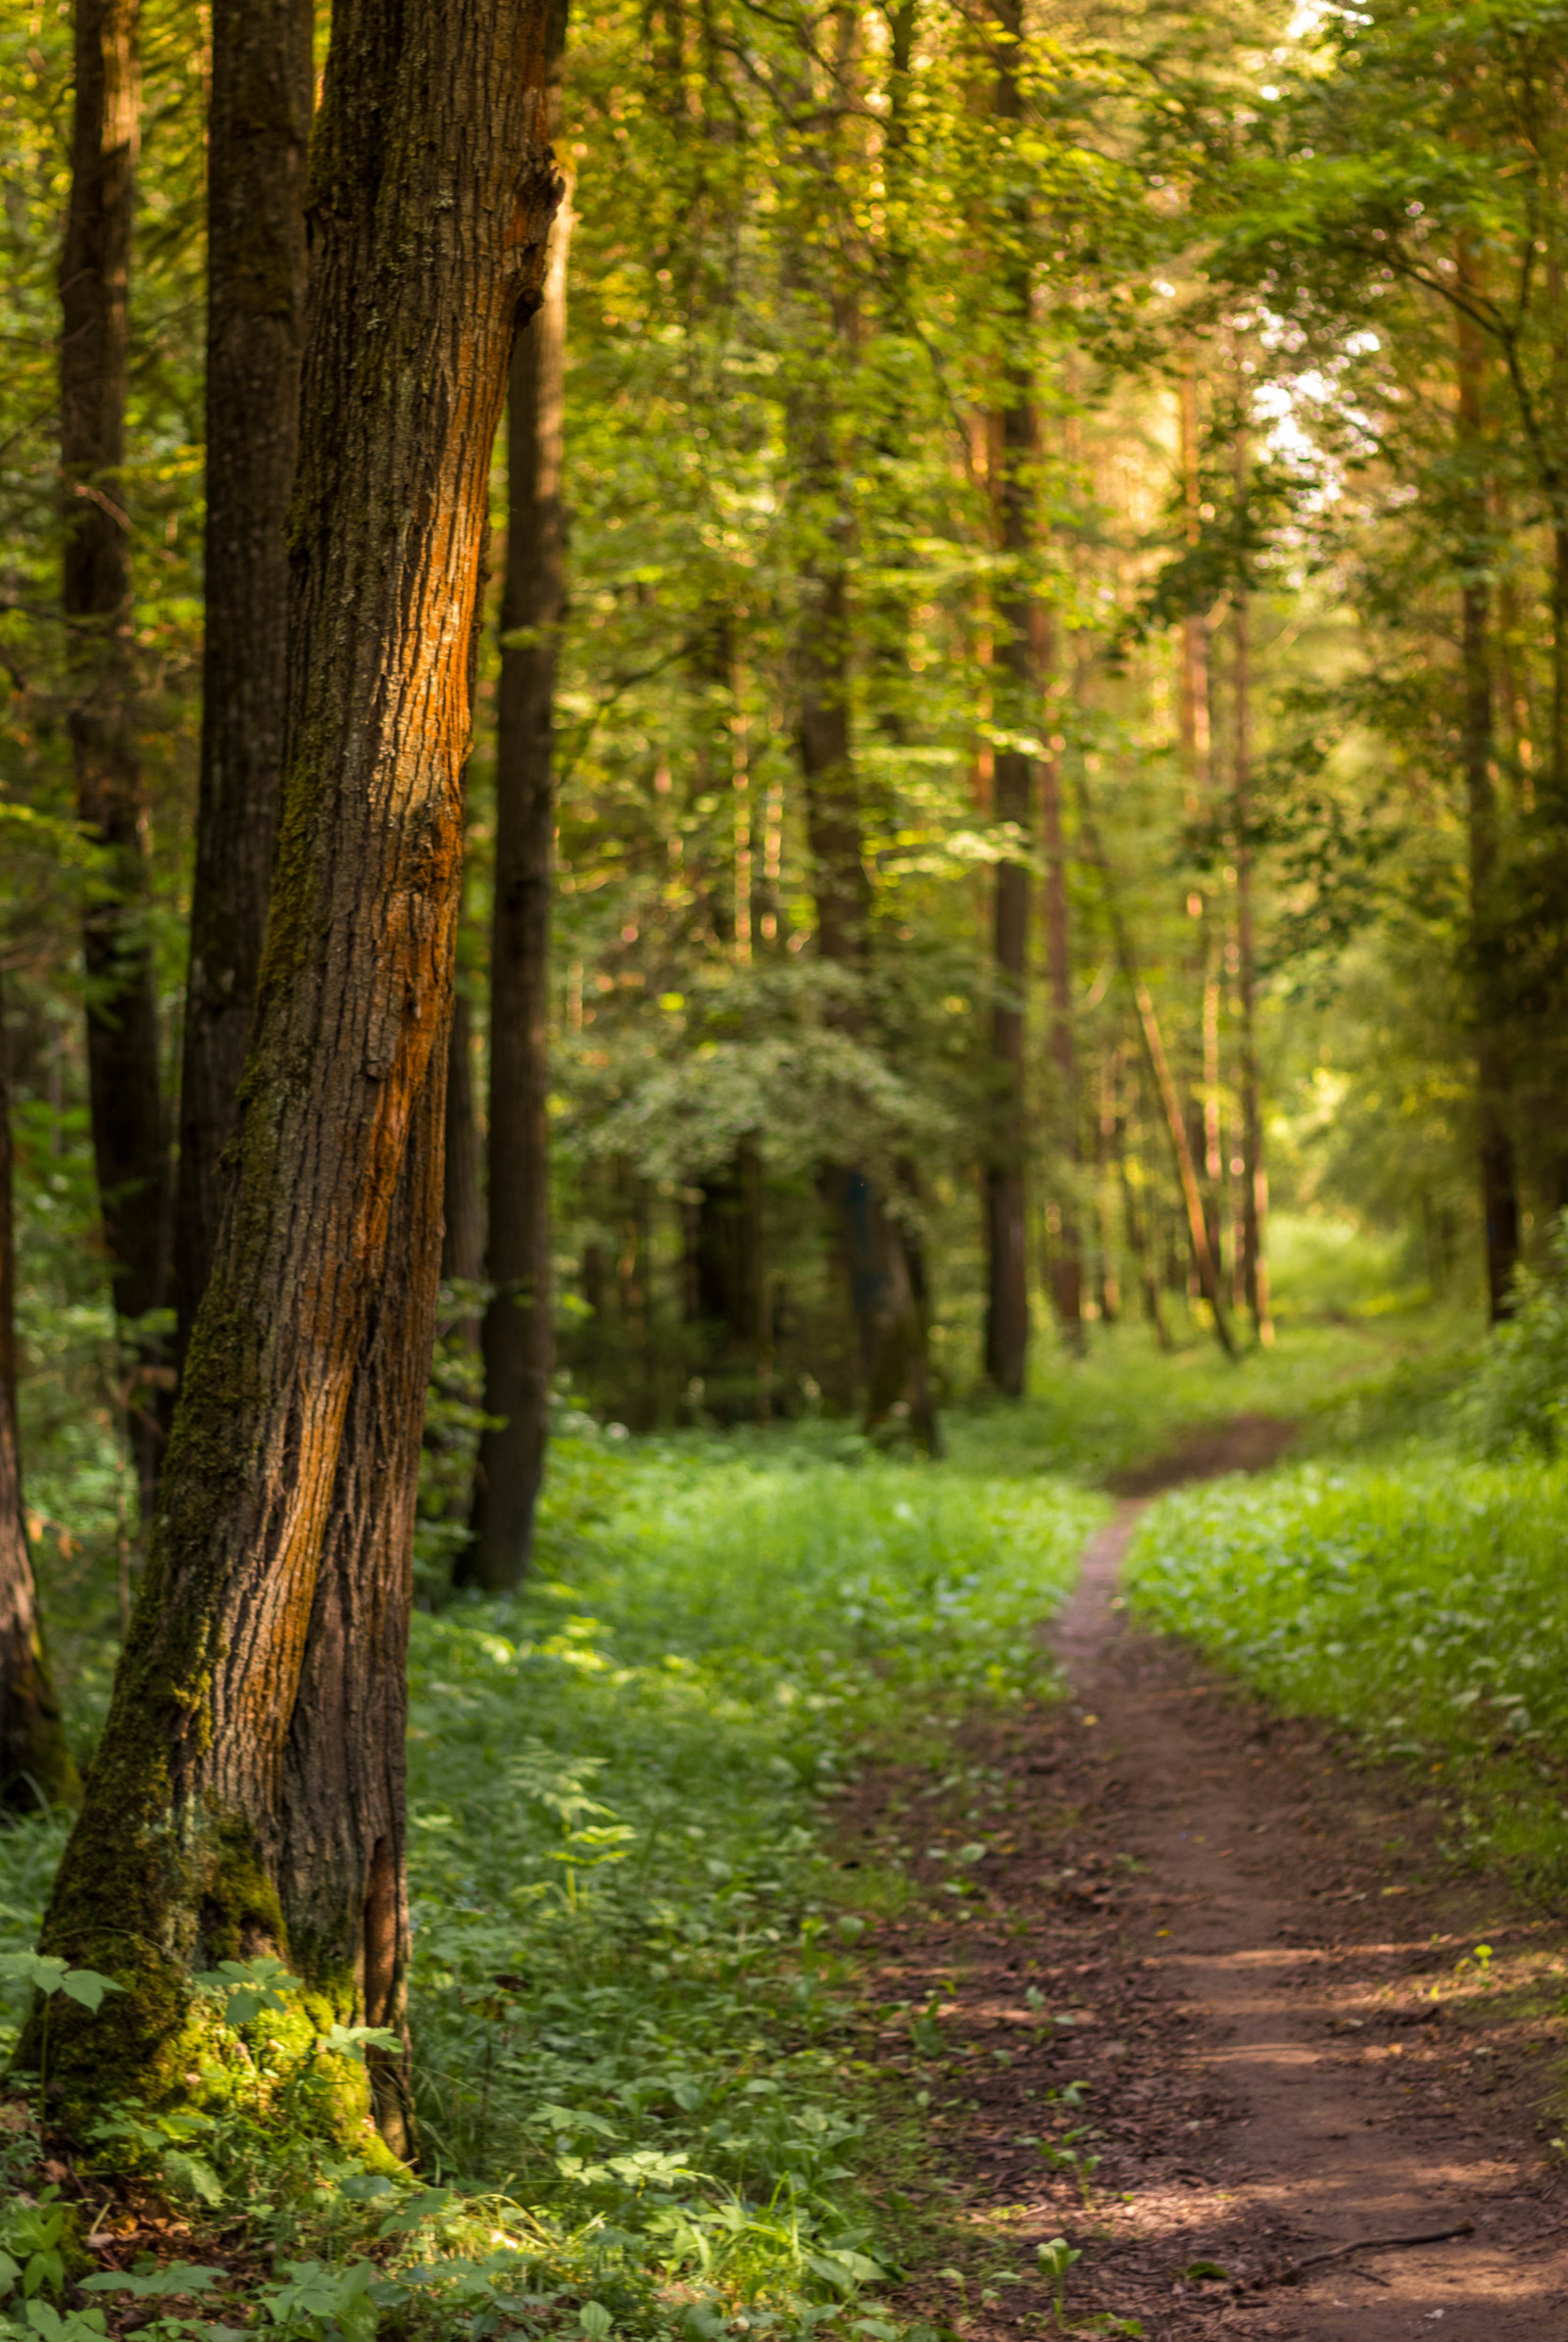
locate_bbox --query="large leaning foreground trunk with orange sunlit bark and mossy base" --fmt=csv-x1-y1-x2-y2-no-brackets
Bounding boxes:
31,0,556,2103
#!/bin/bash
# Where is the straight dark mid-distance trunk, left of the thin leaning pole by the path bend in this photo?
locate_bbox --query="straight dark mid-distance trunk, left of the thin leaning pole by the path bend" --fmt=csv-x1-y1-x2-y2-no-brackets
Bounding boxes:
984,0,1038,1398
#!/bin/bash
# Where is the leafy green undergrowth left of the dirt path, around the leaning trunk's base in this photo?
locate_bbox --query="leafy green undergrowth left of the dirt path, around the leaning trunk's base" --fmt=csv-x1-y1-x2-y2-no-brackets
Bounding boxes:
0,1438,1102,2342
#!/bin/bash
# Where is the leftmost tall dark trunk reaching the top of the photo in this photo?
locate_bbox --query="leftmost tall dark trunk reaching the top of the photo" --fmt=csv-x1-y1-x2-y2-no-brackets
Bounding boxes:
61,0,169,1515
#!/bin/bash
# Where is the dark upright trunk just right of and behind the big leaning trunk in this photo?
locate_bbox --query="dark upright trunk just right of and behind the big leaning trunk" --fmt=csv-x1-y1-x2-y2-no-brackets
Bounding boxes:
468,23,572,1592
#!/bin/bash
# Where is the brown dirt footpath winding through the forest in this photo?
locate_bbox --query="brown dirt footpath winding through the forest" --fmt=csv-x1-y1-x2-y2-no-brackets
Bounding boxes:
846,1417,1568,2342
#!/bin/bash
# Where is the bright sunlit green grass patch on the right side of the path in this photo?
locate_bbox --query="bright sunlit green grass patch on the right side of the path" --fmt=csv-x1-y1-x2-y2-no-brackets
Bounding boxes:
1130,1451,1568,1892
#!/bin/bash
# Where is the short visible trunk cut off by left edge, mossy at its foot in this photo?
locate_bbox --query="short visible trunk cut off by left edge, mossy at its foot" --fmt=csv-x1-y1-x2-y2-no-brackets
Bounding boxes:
0,979,82,1813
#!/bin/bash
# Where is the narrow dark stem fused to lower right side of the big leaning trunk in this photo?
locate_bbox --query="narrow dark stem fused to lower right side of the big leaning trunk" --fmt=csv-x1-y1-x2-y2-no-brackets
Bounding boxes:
279,1051,445,2157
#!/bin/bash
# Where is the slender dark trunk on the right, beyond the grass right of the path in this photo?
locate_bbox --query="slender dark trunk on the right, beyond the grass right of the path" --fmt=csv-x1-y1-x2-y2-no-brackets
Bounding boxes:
1458,268,1518,1326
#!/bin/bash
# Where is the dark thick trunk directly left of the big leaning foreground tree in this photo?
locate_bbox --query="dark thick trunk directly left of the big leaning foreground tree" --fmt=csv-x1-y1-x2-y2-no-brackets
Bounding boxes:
173,0,314,1356
